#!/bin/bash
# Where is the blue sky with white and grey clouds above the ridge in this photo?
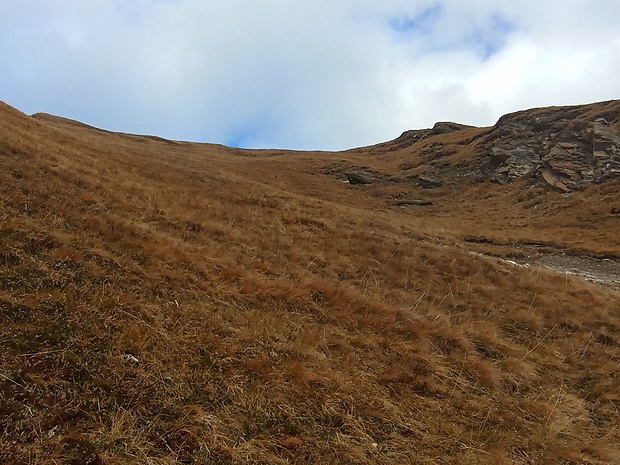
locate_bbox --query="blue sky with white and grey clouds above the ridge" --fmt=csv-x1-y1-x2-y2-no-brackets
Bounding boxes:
0,0,620,150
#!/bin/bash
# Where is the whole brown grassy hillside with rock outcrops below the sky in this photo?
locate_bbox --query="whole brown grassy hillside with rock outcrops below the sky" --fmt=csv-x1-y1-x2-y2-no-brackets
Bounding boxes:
0,101,620,464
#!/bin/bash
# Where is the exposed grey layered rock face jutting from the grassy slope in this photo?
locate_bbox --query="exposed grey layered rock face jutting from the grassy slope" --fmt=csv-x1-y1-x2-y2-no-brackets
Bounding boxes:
483,102,620,188
